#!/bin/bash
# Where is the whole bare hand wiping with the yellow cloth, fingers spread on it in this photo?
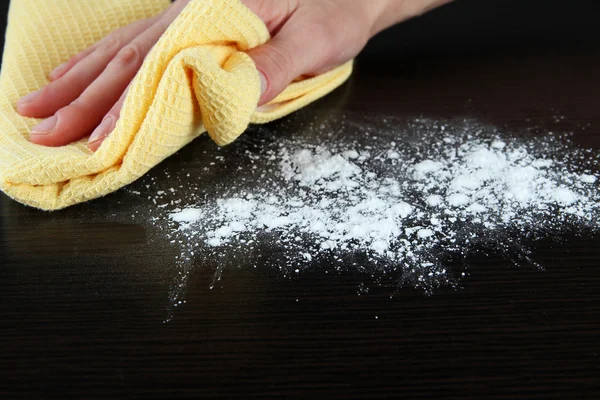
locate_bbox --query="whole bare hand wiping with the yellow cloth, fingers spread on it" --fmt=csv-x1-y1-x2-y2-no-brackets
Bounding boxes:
17,0,450,151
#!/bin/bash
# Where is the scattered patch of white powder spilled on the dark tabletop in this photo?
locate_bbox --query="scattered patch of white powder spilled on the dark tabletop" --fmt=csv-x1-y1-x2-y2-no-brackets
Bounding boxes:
134,116,600,296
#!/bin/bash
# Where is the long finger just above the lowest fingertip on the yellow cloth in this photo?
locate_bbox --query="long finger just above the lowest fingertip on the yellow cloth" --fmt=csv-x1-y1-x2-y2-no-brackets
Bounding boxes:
30,19,173,146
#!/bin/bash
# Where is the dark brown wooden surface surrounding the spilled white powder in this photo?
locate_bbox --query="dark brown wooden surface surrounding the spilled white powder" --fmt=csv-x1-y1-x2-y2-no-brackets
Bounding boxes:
0,0,600,399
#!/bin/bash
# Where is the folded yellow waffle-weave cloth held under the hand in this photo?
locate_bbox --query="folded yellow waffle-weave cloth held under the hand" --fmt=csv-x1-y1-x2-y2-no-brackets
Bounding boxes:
0,0,352,210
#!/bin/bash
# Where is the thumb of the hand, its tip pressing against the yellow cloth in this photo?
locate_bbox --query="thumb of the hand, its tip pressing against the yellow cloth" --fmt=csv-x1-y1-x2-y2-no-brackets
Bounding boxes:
248,26,316,106
